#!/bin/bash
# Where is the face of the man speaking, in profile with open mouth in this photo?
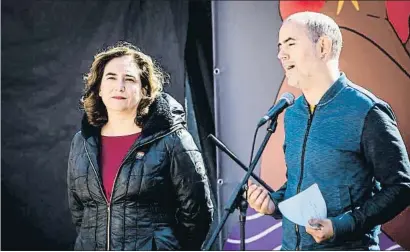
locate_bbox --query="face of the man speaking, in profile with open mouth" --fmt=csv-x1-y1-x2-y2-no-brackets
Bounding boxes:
278,21,321,88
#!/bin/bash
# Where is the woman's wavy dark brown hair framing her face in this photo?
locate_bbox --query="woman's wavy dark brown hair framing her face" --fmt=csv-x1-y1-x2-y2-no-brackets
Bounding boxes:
80,42,167,127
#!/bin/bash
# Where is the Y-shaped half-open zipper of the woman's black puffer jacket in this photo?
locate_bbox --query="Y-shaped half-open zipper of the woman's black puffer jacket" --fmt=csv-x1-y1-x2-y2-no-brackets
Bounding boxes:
84,128,178,250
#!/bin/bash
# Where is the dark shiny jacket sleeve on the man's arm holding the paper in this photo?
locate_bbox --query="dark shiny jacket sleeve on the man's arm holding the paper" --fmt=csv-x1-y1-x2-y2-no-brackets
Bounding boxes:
330,104,410,240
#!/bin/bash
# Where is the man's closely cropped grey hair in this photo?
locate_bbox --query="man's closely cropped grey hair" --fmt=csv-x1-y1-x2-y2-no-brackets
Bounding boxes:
285,11,343,59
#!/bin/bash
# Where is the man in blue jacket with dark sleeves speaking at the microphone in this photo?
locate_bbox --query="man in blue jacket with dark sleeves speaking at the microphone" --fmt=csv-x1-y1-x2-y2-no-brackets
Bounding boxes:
248,12,410,250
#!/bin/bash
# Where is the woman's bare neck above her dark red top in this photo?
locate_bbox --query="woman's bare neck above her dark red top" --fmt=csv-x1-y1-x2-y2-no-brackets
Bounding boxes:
101,112,141,136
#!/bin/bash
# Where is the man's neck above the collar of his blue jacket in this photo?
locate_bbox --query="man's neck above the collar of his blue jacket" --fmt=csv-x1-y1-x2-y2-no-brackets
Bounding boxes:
301,64,340,106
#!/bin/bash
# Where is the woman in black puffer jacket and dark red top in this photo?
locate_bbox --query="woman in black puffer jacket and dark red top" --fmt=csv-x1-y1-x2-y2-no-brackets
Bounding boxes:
67,43,213,250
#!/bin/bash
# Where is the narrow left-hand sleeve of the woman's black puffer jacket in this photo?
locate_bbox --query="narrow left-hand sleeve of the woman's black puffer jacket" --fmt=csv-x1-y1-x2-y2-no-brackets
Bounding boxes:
67,137,84,234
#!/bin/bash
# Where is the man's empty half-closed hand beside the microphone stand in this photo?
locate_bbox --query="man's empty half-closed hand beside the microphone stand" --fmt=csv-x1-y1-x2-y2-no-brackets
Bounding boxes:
248,180,275,214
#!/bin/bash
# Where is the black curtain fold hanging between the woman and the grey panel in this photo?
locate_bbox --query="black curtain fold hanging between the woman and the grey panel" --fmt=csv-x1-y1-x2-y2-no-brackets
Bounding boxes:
185,1,220,250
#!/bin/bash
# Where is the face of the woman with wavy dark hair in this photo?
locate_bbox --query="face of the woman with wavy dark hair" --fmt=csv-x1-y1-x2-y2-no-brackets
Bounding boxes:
99,55,142,115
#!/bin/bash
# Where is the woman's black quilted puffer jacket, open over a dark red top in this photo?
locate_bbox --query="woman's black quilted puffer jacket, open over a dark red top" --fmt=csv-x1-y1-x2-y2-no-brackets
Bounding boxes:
67,93,213,250
